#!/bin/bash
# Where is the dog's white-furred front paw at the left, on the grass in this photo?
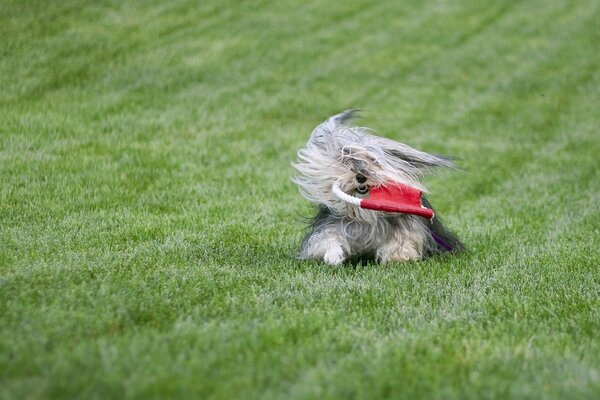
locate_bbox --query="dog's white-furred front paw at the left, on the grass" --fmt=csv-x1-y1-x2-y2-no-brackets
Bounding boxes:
300,228,348,265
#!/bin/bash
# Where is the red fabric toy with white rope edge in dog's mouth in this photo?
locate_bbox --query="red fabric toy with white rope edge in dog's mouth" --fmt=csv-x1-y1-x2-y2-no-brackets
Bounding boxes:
332,182,435,218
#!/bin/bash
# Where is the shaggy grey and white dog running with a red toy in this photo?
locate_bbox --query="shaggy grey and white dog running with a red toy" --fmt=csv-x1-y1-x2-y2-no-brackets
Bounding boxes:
292,110,465,266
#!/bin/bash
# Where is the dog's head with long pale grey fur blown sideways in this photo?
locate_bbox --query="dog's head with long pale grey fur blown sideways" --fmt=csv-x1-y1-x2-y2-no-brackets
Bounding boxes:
293,110,452,219
